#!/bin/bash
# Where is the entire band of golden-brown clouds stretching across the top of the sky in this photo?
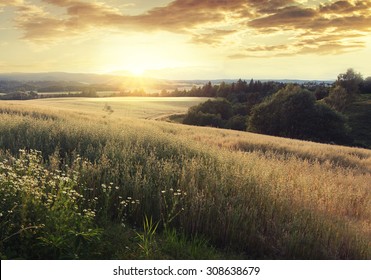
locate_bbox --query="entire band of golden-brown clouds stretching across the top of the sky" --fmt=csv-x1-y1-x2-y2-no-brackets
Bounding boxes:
4,0,371,58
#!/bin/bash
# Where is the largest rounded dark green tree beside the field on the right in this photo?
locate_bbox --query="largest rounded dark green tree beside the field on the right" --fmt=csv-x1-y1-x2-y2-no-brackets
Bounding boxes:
248,85,347,143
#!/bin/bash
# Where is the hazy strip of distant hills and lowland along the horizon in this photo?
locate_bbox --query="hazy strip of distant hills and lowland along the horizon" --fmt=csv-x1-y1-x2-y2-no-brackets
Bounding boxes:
0,72,333,93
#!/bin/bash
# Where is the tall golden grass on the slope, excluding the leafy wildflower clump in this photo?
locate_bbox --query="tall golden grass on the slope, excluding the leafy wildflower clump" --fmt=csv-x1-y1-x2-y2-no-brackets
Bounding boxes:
0,106,371,259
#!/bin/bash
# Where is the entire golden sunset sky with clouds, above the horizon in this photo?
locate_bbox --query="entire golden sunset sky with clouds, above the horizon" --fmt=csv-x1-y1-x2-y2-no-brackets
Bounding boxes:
0,0,371,80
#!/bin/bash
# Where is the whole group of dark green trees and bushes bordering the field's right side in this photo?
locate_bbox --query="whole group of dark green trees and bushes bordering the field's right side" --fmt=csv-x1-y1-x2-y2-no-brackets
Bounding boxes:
183,69,371,145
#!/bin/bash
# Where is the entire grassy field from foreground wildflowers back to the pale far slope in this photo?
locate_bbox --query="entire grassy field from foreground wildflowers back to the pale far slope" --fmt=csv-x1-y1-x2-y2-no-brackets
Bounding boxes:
0,99,371,259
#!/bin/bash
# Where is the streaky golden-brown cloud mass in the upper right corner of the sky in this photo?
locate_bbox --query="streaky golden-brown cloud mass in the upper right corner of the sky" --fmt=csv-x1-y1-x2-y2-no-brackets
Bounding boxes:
244,1,371,57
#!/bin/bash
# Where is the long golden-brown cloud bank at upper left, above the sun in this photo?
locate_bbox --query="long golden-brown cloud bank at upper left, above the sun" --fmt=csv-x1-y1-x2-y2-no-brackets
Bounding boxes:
10,0,250,42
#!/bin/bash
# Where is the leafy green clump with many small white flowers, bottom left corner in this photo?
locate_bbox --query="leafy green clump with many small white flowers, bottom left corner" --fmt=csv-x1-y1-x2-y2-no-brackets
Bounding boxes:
0,150,101,259
